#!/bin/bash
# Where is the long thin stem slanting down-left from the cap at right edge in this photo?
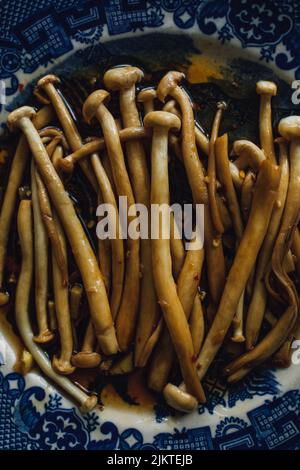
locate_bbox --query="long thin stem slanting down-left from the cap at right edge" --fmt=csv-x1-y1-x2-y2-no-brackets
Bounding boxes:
246,136,289,350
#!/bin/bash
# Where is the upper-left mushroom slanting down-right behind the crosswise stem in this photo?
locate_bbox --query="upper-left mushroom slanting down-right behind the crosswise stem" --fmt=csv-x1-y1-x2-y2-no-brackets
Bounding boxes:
36,75,97,191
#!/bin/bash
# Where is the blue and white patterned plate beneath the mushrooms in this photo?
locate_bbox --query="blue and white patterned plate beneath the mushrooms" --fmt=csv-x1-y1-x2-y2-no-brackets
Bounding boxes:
0,0,300,450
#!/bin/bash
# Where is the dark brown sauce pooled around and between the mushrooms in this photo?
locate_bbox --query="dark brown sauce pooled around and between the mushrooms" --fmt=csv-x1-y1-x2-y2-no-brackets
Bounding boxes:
0,35,293,415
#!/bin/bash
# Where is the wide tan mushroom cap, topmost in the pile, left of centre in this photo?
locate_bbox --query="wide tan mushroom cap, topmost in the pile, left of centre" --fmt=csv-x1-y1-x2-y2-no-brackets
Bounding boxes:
103,66,144,91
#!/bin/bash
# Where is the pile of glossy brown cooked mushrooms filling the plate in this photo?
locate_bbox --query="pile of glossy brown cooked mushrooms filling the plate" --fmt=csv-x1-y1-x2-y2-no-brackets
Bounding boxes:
0,66,300,412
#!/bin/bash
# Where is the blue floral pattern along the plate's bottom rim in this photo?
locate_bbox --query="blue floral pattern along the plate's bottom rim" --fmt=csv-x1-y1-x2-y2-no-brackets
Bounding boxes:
0,366,300,450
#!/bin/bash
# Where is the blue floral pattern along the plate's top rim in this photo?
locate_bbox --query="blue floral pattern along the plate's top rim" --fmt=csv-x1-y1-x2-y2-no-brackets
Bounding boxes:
0,0,300,89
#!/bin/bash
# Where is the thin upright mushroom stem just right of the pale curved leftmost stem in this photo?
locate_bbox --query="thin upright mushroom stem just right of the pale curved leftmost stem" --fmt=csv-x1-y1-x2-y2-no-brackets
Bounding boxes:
31,160,54,343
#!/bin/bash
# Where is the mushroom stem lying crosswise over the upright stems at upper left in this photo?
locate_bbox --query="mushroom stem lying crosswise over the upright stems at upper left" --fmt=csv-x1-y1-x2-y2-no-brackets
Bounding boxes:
61,127,149,173
